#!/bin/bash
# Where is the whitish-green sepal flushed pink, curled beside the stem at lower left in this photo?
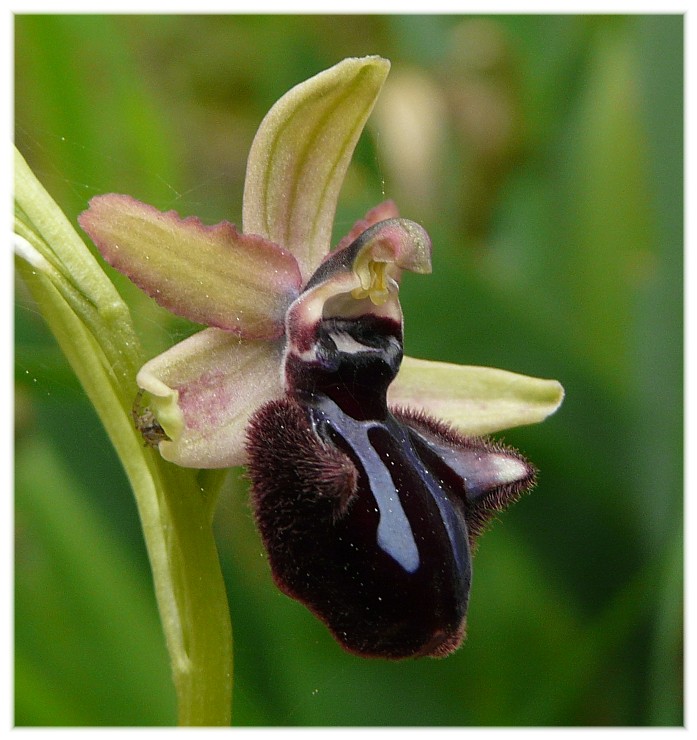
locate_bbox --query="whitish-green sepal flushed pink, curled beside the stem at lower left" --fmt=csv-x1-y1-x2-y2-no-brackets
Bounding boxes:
136,329,283,468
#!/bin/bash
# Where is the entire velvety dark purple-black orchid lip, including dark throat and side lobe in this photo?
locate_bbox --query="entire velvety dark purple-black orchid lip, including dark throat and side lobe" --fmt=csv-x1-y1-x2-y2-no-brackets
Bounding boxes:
242,224,535,658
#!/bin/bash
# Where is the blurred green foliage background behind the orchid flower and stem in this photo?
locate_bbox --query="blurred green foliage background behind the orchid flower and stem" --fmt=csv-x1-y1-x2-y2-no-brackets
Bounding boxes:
15,15,683,726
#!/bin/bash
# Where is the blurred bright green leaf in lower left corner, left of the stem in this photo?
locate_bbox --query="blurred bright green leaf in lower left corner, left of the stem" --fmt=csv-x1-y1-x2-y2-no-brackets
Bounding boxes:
15,434,175,726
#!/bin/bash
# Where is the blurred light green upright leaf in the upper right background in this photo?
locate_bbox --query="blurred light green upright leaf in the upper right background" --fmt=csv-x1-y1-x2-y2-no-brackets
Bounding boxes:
560,27,655,392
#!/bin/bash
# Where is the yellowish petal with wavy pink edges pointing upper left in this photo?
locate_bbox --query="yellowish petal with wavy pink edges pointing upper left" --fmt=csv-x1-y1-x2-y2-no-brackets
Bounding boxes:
79,194,301,339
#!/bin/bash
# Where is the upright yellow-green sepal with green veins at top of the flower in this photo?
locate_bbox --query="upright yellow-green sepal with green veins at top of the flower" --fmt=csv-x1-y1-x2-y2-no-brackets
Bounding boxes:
242,57,390,280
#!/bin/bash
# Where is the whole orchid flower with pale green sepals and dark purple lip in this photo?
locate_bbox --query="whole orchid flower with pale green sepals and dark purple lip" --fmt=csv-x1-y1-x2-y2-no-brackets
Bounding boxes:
80,57,563,658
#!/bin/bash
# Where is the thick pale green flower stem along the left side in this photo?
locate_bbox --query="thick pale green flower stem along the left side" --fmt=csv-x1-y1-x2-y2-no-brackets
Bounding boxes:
15,154,232,726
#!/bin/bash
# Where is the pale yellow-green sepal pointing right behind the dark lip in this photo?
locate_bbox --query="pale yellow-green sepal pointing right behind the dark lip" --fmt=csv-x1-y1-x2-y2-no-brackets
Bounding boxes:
387,357,564,434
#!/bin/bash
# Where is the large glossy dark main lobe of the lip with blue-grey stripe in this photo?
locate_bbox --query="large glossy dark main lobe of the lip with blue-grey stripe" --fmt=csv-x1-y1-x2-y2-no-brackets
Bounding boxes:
249,397,470,658
